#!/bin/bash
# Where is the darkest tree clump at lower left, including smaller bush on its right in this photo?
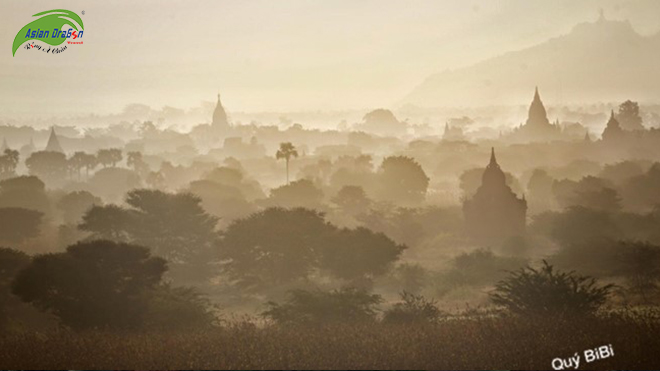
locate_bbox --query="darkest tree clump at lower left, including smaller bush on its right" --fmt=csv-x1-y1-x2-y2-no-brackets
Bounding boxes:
6,240,216,330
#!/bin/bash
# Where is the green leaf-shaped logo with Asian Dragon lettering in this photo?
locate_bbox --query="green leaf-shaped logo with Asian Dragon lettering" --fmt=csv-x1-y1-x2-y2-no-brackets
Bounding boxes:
11,9,83,56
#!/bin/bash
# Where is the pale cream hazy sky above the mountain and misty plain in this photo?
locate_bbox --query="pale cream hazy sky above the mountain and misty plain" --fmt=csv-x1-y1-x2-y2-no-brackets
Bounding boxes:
0,0,660,117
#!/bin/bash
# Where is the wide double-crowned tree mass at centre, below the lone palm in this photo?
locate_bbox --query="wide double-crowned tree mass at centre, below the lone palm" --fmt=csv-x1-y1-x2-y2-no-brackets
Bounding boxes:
221,208,405,290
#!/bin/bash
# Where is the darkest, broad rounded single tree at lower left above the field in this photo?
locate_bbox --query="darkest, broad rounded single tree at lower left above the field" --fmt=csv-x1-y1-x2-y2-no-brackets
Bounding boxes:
13,241,167,329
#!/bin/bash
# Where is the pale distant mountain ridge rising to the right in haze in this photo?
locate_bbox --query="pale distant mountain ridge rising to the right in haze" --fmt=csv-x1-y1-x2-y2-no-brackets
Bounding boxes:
401,17,660,107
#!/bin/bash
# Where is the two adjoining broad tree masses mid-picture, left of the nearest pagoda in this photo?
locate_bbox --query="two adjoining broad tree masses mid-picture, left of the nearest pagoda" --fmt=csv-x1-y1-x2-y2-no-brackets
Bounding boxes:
73,189,405,289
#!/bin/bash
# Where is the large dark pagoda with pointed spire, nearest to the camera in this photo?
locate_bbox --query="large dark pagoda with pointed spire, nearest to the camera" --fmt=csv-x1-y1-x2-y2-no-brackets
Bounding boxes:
463,148,527,244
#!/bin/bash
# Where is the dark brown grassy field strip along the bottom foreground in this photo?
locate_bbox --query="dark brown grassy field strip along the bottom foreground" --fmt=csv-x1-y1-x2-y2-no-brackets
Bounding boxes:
0,316,660,370
